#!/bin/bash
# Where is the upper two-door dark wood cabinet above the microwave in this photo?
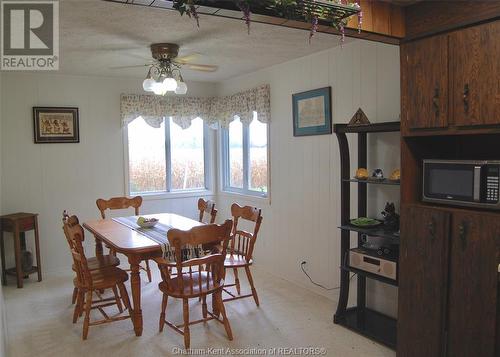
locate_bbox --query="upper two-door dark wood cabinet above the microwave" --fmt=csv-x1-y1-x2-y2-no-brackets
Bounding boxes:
401,20,500,135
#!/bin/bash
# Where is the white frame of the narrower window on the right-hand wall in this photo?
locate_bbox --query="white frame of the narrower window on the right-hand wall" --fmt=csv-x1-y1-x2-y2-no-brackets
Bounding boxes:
220,116,271,199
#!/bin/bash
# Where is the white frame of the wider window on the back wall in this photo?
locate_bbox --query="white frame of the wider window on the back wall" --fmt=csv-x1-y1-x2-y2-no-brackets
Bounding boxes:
123,117,214,199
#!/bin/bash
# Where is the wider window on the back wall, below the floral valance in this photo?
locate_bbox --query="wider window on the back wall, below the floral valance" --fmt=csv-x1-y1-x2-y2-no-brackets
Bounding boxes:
127,117,208,194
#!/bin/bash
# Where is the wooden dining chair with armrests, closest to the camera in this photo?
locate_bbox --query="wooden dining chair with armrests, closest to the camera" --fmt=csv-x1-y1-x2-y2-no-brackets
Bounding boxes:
155,220,233,349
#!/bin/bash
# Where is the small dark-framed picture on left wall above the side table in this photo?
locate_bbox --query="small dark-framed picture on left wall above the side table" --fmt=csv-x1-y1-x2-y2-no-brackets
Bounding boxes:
33,107,80,144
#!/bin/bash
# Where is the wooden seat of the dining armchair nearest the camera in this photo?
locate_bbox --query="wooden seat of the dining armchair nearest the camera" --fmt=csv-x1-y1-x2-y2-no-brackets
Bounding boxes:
158,271,224,298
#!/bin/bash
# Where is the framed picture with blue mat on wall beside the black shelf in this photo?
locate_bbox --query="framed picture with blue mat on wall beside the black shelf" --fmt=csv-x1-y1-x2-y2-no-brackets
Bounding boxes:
292,87,332,136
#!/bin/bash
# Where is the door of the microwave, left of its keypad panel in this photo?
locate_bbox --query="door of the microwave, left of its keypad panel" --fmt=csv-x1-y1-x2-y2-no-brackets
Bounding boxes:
424,163,481,202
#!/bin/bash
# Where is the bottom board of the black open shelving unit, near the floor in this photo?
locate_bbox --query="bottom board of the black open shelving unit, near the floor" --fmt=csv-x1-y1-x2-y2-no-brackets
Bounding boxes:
334,307,397,349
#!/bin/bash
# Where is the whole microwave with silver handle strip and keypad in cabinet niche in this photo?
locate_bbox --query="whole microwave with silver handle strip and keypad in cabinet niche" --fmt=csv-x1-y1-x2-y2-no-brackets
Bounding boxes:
422,160,500,210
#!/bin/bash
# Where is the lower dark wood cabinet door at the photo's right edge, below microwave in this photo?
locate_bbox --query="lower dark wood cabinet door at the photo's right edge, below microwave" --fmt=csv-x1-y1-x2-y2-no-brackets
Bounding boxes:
447,212,500,357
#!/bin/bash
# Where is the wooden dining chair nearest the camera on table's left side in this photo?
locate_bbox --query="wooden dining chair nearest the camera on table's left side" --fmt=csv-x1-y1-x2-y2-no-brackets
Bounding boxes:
63,216,131,340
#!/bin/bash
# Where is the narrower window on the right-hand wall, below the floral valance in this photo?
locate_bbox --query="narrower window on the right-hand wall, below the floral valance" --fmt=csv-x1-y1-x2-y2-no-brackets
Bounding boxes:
222,112,268,196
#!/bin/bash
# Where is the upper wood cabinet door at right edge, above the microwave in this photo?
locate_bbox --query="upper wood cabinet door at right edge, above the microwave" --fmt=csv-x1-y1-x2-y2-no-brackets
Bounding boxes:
450,21,500,126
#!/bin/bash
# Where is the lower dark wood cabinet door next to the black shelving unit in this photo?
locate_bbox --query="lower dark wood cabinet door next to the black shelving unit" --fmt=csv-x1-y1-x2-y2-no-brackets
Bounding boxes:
397,207,450,357
